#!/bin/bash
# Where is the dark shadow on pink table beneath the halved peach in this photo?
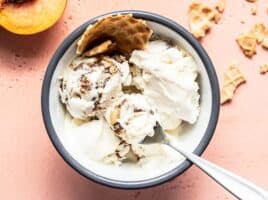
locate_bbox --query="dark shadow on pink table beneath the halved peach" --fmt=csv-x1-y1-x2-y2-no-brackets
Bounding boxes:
0,18,68,69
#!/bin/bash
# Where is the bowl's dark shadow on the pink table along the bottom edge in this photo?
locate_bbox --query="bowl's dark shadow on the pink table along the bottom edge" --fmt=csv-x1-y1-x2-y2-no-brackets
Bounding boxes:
47,152,195,200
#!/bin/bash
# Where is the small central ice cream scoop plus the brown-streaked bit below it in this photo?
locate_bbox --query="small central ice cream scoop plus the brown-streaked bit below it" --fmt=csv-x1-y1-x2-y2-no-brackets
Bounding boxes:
105,94,157,162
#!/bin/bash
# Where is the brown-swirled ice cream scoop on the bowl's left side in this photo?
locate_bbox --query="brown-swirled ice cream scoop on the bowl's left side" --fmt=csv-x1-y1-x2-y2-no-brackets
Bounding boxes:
59,57,130,119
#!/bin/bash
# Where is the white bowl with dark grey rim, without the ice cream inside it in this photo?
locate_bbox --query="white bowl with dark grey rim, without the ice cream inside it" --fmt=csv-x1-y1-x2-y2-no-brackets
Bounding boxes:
42,11,219,188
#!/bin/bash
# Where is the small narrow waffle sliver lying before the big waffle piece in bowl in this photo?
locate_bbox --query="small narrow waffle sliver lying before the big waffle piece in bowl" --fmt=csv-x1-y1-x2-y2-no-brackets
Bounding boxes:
83,40,116,57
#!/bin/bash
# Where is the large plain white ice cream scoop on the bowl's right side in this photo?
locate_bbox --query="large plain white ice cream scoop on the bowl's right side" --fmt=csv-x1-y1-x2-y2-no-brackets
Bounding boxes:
130,40,199,130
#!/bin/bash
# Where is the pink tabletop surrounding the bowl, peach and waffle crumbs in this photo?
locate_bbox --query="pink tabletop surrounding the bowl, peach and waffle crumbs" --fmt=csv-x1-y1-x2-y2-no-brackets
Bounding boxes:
0,0,268,200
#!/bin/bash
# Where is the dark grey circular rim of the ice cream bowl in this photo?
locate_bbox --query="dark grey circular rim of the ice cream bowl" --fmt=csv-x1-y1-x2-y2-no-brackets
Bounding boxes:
41,10,220,189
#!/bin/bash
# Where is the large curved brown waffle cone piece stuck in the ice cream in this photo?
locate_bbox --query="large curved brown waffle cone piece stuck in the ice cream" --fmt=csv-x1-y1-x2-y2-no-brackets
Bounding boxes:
76,14,153,55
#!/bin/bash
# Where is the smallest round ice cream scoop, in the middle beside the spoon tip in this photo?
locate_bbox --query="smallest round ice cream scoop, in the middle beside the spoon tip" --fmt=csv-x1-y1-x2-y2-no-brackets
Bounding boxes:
106,94,156,144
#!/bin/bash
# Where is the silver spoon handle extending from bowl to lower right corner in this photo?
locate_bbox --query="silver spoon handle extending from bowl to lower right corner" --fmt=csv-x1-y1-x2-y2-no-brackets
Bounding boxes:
170,145,268,200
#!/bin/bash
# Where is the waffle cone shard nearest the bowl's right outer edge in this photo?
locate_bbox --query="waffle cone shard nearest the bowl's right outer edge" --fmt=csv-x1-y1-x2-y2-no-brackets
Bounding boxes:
221,64,246,104
